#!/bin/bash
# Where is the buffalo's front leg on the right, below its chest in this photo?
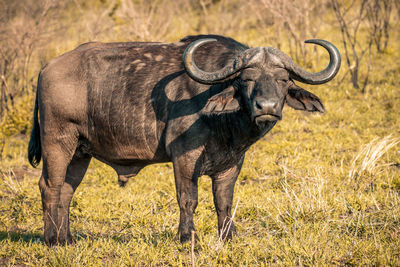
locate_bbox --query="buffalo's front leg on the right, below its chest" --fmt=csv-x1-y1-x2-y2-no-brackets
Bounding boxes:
211,161,243,240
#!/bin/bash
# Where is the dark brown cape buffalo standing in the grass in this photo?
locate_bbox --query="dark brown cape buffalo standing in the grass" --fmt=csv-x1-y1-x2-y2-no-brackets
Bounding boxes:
28,35,341,244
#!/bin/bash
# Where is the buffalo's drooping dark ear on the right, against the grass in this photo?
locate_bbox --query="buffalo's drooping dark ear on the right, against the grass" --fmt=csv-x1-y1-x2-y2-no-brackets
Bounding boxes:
286,83,325,113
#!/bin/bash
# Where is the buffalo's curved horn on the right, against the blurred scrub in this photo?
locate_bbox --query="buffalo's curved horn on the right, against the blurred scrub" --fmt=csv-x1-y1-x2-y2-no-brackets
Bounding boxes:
276,39,341,84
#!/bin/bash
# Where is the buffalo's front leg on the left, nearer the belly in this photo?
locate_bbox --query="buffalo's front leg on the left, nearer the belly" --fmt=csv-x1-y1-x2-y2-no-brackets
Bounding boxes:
173,153,199,243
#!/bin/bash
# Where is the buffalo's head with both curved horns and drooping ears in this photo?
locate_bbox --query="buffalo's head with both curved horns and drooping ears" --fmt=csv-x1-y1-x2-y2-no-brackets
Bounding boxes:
183,38,341,125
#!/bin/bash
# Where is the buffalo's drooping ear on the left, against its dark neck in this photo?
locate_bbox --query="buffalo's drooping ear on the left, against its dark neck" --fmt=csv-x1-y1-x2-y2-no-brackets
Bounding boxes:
201,86,240,115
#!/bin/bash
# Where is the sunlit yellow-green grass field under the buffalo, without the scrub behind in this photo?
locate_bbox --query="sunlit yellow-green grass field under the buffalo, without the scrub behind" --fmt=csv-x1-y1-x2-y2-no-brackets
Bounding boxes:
0,0,400,266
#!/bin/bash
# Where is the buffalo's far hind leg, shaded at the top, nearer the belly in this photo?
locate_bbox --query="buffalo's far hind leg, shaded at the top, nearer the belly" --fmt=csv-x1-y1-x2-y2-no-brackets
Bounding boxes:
58,153,91,244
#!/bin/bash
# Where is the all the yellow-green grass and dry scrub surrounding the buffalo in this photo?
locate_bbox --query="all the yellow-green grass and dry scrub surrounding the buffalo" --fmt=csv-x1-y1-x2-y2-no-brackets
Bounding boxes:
0,0,400,266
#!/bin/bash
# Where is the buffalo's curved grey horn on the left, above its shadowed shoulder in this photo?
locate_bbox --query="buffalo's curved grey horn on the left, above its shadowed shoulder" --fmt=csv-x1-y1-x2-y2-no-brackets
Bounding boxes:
183,38,249,84
